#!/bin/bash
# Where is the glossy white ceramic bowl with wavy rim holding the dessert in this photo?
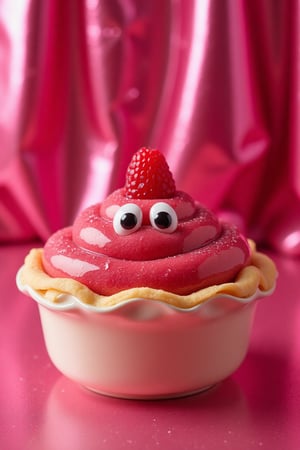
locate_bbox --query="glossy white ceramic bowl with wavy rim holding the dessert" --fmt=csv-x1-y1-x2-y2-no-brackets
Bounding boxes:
17,272,270,399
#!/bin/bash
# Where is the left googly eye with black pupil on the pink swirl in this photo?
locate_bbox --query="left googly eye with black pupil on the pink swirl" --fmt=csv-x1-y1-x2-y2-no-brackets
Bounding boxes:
113,203,143,236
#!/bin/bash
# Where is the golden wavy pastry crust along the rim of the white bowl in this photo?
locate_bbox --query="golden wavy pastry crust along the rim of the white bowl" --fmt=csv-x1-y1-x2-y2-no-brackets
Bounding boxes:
20,240,277,309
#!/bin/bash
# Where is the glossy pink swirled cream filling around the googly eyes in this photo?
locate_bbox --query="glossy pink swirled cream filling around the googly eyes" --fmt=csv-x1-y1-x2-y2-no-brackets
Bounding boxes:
43,189,249,295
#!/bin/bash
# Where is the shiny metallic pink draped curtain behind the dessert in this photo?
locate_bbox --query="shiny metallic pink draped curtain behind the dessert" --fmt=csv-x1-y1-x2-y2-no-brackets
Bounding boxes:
0,0,300,255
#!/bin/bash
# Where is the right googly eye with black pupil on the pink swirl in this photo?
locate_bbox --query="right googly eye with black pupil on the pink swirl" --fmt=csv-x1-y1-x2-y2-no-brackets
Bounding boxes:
150,202,178,233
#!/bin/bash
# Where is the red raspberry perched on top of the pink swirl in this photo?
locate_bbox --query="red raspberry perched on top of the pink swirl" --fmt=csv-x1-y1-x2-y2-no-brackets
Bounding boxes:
125,147,176,199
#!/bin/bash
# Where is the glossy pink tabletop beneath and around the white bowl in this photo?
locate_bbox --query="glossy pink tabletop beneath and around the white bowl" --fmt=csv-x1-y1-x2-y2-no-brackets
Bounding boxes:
0,245,300,450
